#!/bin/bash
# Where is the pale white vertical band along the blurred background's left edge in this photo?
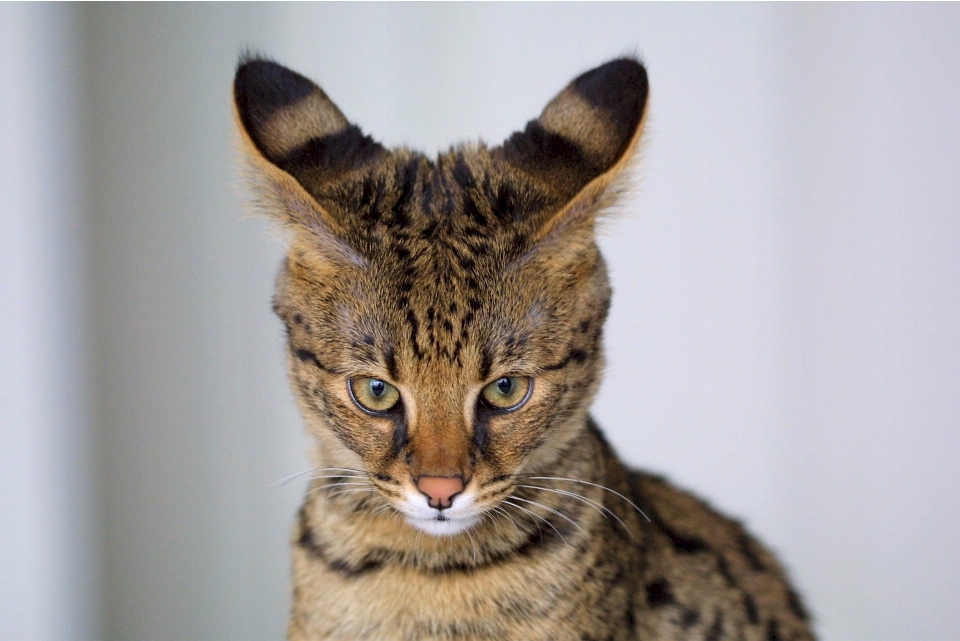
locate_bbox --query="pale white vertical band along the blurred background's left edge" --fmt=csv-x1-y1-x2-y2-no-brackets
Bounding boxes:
0,3,98,641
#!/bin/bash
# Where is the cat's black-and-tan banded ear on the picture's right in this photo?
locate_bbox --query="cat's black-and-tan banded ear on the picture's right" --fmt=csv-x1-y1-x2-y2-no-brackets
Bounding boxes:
493,58,648,242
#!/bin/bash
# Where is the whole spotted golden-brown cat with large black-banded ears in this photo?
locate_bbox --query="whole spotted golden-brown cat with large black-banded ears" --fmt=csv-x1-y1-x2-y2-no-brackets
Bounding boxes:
234,57,812,641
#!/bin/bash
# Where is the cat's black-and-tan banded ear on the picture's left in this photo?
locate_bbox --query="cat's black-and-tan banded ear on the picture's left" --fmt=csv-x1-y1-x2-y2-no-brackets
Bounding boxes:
233,58,387,263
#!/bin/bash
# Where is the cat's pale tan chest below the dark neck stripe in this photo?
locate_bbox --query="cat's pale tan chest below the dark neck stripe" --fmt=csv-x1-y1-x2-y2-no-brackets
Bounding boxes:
290,553,624,641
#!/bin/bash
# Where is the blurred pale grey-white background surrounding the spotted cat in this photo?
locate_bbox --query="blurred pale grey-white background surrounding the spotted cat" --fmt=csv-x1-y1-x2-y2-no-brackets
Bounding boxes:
0,3,960,641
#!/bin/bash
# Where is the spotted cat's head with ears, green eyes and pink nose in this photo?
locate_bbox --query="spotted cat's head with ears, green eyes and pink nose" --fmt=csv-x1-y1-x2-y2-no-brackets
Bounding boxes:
234,58,647,535
